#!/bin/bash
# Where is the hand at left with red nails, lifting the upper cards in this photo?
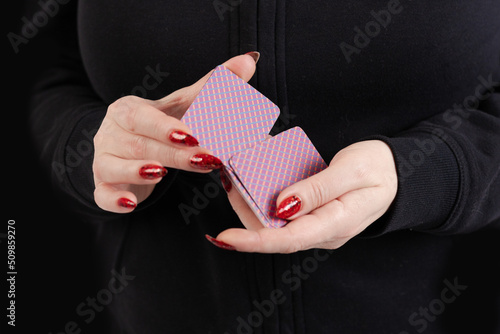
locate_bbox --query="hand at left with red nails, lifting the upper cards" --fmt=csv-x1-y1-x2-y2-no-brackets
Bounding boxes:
92,55,255,213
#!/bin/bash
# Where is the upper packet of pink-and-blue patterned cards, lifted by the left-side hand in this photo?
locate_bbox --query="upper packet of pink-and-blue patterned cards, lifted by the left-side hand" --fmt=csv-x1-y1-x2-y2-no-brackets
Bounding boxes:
182,65,280,165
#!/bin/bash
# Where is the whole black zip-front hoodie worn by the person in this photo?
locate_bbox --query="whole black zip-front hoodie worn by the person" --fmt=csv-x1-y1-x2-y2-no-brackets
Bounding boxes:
31,0,500,334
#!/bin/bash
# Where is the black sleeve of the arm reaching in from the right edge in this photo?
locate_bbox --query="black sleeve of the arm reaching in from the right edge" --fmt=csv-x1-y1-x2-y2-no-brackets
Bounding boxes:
364,72,500,236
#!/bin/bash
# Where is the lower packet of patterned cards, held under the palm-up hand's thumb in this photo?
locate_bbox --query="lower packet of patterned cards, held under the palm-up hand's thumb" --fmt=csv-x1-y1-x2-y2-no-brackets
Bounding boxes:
229,127,327,228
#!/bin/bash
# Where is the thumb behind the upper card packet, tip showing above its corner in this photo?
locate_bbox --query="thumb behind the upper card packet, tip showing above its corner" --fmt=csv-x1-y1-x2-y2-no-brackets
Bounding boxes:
153,51,260,119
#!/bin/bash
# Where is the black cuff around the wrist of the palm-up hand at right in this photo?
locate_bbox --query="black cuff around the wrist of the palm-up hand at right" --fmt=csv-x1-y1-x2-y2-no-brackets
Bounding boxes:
360,128,460,237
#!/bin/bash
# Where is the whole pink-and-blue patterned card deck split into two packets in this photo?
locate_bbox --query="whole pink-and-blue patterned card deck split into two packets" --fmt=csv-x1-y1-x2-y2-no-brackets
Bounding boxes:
182,65,327,228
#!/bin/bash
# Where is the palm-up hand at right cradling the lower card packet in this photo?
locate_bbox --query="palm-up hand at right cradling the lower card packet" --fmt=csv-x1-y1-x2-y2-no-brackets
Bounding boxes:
217,140,398,253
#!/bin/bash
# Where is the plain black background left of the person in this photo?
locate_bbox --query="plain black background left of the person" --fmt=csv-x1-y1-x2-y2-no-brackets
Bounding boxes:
5,0,102,334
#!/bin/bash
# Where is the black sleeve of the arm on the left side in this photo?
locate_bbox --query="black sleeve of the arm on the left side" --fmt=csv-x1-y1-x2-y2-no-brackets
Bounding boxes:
30,2,176,215
